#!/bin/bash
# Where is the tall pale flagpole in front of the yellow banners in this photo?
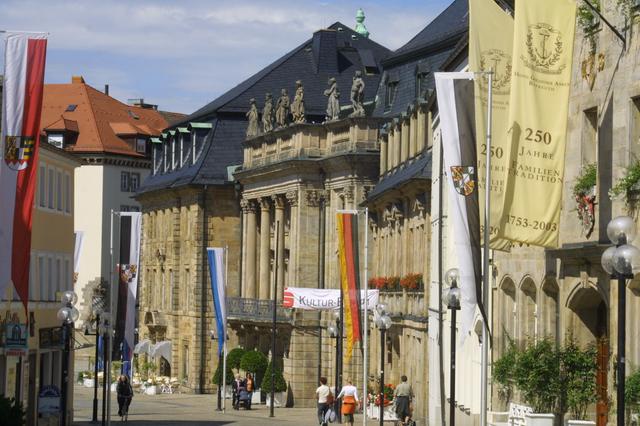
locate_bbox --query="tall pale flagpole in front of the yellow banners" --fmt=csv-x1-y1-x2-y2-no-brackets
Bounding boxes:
480,68,493,426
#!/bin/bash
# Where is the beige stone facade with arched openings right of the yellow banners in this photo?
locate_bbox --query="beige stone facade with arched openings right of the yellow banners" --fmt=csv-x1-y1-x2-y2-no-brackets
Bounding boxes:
491,0,640,425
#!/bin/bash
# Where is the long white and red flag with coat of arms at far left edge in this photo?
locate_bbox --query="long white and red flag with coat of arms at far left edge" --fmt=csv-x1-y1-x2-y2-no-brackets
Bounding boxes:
0,32,47,311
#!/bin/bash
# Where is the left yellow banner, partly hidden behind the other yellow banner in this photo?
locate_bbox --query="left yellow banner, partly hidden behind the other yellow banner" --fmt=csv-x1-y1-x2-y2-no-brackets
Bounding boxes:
469,0,513,250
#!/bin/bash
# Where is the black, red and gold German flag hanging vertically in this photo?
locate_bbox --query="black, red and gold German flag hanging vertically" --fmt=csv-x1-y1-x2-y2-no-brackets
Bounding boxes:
337,213,362,360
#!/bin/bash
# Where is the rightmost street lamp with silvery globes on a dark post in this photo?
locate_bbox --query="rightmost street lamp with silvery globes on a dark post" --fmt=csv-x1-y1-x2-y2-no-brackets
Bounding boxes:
602,216,640,426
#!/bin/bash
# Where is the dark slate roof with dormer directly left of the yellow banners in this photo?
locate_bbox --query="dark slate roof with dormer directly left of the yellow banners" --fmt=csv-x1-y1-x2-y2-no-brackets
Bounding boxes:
374,0,469,117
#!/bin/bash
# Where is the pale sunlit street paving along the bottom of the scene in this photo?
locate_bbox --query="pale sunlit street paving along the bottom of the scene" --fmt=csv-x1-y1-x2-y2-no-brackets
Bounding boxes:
74,385,358,426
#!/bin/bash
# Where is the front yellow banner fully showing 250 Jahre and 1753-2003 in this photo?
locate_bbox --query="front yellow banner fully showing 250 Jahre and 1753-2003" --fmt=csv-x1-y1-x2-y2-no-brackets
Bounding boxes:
498,0,576,247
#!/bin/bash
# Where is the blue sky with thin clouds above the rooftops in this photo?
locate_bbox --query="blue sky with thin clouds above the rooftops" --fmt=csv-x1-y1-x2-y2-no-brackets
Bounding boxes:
0,0,452,114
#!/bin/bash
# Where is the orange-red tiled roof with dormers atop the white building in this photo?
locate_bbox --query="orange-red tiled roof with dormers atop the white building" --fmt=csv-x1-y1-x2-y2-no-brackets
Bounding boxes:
40,78,181,157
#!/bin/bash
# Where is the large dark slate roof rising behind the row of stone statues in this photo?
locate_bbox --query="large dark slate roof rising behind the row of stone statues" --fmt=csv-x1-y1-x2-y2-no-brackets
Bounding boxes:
139,22,391,193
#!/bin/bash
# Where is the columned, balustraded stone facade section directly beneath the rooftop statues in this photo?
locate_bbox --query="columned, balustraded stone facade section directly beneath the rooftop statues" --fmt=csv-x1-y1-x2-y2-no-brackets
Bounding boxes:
236,118,380,407
